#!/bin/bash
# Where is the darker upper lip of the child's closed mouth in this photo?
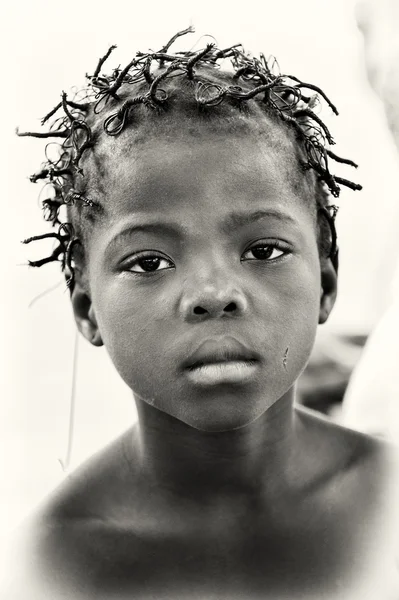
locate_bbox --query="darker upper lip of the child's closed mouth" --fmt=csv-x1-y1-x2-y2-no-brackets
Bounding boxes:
183,337,260,370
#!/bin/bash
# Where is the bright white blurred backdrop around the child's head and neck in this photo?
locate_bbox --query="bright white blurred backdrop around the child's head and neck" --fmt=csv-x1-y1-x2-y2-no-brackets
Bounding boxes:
0,0,399,530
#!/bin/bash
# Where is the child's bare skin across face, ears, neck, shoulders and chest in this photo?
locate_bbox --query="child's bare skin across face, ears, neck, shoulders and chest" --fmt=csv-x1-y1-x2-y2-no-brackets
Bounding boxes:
18,128,394,600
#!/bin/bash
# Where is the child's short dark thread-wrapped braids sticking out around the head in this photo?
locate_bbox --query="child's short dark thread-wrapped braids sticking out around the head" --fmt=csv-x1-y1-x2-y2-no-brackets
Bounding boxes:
17,27,361,287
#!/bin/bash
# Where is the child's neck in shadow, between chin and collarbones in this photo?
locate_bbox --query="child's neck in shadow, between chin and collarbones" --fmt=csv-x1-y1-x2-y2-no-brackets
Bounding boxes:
136,390,296,497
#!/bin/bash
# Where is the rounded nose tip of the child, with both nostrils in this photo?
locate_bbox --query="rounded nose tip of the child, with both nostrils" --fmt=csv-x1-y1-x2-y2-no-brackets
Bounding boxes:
181,280,248,321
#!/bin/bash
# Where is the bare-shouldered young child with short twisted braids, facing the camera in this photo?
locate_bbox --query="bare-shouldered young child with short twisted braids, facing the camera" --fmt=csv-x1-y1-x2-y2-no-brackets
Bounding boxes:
13,30,393,600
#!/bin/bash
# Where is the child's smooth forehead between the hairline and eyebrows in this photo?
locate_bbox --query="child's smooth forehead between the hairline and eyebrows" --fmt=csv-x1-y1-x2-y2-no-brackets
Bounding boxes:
86,128,314,221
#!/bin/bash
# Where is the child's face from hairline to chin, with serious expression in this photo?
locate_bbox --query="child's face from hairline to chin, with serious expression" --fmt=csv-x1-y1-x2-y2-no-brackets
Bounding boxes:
82,132,328,431
